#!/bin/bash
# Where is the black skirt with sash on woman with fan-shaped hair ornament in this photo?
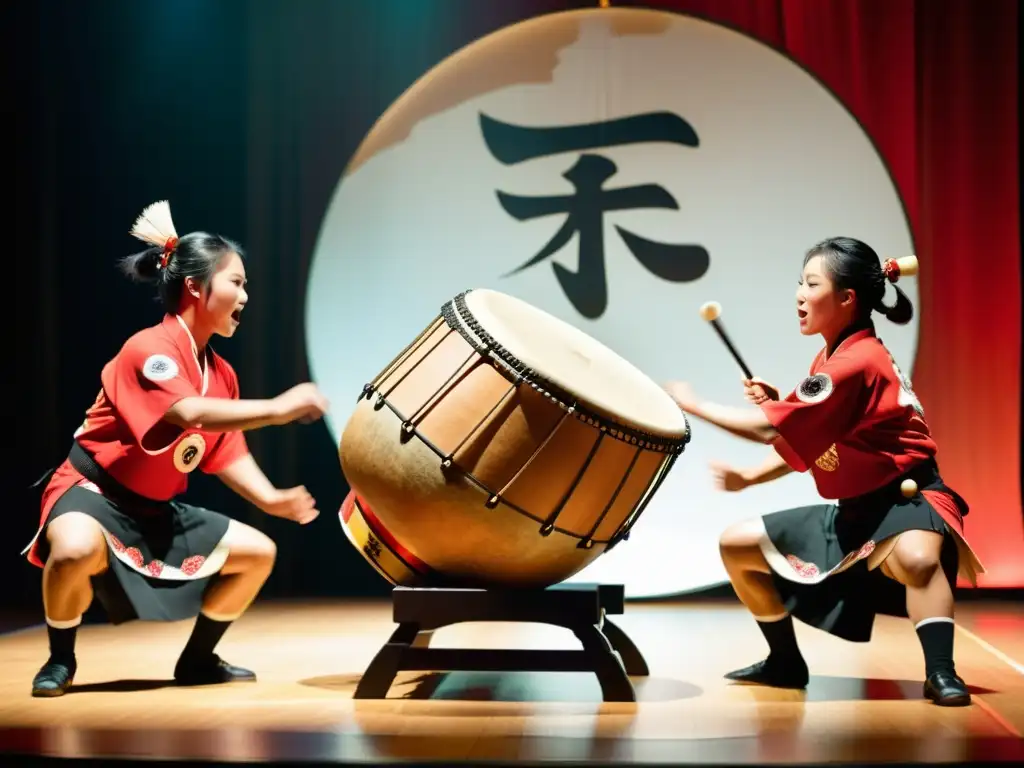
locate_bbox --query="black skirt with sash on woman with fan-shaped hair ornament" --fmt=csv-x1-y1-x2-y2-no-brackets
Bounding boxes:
32,443,231,624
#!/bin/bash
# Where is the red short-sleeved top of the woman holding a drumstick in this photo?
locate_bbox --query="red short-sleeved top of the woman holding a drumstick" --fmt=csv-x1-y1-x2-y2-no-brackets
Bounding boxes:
761,329,937,499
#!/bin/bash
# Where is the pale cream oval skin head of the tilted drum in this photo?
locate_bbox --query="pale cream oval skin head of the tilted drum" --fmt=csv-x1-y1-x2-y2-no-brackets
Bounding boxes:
465,289,686,438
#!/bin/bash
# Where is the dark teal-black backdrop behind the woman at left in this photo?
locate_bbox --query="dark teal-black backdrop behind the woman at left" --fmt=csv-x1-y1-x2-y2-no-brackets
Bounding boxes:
8,0,1024,609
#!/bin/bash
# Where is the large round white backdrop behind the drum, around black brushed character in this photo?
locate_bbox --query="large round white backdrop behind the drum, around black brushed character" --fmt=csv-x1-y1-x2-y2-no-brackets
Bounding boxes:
306,8,918,597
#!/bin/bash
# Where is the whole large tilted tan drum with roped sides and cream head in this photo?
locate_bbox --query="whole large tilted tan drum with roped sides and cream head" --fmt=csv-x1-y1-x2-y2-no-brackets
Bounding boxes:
339,290,689,588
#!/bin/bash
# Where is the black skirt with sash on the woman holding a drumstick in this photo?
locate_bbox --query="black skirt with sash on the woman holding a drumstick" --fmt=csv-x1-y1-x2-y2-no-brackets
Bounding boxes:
761,463,967,642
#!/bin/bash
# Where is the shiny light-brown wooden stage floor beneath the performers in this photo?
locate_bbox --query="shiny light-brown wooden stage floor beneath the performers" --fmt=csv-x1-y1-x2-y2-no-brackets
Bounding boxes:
0,600,1024,765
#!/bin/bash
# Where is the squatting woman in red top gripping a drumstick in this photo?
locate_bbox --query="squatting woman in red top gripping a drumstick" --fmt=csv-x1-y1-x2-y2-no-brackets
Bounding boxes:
666,238,984,706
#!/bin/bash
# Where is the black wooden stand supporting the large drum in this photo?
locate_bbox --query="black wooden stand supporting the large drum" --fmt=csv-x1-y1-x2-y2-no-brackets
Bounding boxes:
354,584,650,701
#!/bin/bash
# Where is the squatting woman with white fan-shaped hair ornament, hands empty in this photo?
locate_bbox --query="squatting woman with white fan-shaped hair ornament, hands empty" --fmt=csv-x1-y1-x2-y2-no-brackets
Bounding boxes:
23,201,328,696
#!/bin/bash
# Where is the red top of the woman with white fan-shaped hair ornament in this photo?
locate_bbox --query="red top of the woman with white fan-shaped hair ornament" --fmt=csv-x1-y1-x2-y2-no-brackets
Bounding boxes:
29,314,249,565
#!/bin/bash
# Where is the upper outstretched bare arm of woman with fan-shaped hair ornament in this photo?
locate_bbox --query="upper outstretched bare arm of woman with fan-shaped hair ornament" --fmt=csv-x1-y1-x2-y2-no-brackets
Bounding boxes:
164,384,327,432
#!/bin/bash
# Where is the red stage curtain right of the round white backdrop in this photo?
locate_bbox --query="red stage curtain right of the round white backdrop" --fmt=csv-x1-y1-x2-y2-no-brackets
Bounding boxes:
638,0,1024,587
